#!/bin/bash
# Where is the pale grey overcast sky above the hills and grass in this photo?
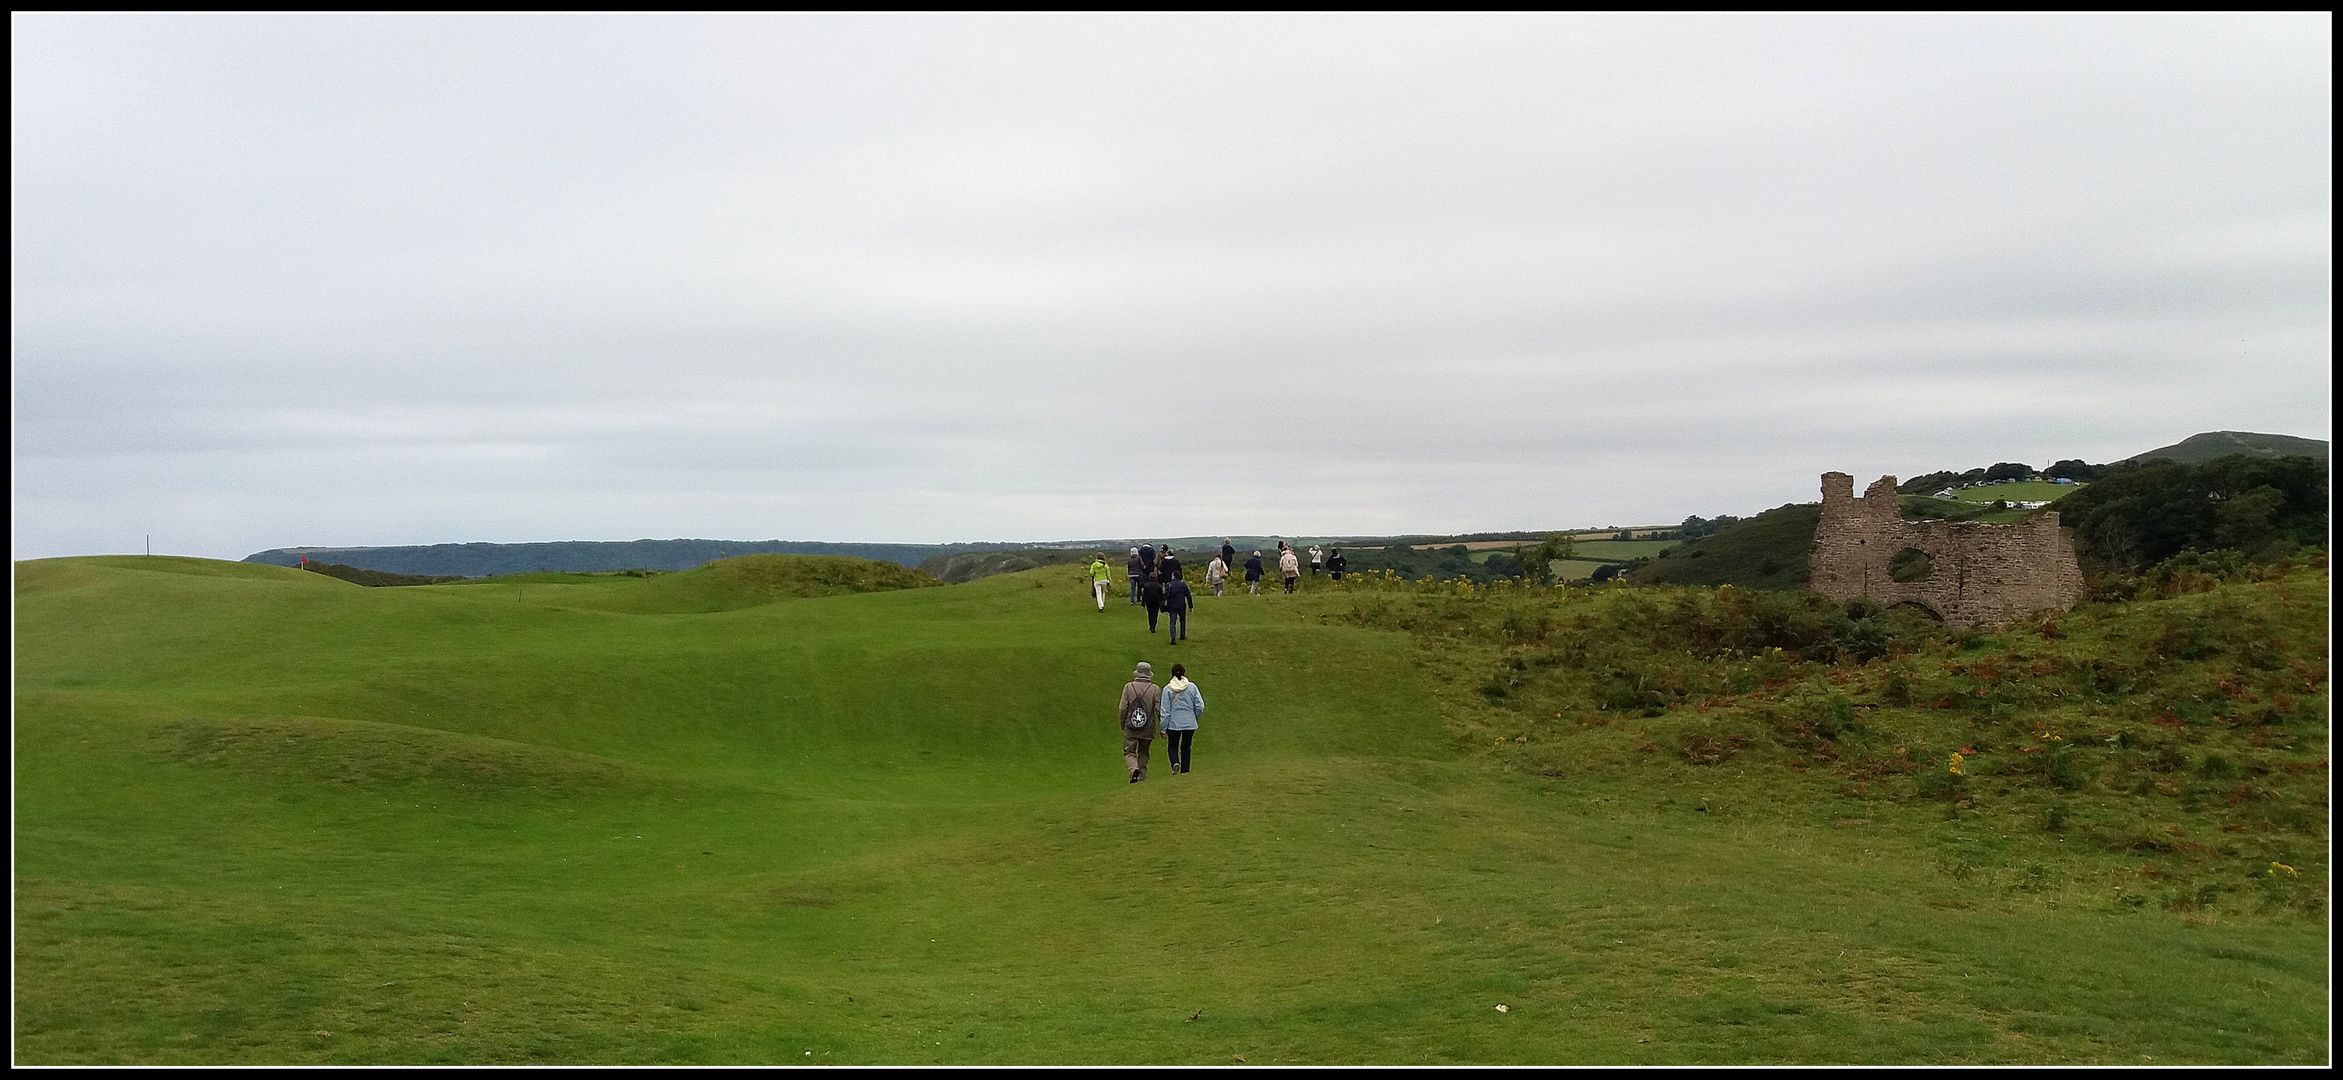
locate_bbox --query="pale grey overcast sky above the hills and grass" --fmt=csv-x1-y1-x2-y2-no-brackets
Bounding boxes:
9,14,2334,558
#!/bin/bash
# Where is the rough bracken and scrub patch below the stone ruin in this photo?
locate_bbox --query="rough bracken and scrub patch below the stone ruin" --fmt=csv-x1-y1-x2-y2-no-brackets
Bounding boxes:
1350,553,2329,918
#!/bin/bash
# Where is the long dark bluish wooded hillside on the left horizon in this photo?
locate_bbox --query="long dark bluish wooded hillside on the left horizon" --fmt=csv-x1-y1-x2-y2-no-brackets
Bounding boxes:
244,539,1010,576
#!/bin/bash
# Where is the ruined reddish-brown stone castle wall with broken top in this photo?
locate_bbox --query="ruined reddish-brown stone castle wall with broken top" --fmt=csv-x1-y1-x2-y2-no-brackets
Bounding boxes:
1809,473,2083,626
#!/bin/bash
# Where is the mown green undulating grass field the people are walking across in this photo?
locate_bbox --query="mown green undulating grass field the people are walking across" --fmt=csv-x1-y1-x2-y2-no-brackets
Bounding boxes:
14,558,2327,1064
